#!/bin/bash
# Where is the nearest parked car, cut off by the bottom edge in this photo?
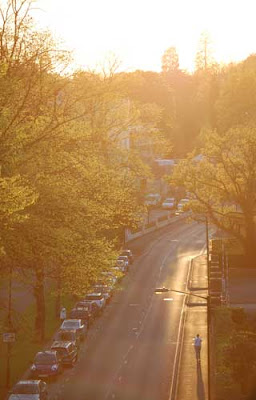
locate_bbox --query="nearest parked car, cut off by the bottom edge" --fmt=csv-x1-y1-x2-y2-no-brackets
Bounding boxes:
8,380,48,400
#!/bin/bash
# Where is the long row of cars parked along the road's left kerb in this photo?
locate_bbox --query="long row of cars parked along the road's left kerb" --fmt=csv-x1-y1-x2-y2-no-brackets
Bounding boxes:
8,249,133,400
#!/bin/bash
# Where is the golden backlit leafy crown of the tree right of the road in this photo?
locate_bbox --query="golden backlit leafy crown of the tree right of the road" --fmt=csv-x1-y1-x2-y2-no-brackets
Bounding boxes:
170,126,256,266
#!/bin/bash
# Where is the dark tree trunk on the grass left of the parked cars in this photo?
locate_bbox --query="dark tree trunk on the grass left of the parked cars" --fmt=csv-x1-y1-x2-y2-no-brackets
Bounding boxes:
34,266,45,342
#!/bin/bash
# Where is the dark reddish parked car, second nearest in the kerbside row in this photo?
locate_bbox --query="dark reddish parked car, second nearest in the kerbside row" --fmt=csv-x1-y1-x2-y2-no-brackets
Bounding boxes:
30,350,62,378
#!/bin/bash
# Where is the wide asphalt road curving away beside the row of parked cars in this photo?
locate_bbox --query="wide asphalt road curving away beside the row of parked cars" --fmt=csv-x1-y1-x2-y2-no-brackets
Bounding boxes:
49,222,205,400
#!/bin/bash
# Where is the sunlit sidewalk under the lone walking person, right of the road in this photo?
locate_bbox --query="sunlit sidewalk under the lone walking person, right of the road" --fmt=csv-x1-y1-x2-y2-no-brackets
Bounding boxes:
175,255,208,400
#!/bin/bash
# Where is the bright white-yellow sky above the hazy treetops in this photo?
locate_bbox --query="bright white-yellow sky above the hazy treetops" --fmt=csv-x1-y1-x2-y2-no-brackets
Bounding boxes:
36,0,256,71
